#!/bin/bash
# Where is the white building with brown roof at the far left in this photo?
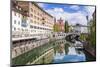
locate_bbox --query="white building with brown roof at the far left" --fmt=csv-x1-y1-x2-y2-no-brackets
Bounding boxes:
12,1,30,40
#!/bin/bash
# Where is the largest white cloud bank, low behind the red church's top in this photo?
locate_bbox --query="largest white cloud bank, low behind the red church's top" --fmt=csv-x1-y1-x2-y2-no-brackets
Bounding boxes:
46,8,87,25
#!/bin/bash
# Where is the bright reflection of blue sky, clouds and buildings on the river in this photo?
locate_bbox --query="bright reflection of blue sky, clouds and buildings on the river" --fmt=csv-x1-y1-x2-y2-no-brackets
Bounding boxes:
52,40,86,63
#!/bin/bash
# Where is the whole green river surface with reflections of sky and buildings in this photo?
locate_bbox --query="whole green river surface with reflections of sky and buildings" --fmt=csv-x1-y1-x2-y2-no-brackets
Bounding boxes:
12,39,94,65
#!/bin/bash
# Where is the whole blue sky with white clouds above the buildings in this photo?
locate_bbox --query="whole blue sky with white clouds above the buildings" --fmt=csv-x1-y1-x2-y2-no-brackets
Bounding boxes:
37,3,95,25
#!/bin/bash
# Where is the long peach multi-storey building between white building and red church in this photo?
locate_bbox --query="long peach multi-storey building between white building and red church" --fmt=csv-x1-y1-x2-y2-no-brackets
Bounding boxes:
29,2,54,37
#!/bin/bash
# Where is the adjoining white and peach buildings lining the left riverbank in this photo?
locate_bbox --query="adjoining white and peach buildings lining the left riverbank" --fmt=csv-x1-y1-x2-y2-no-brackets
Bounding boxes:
12,1,54,40
